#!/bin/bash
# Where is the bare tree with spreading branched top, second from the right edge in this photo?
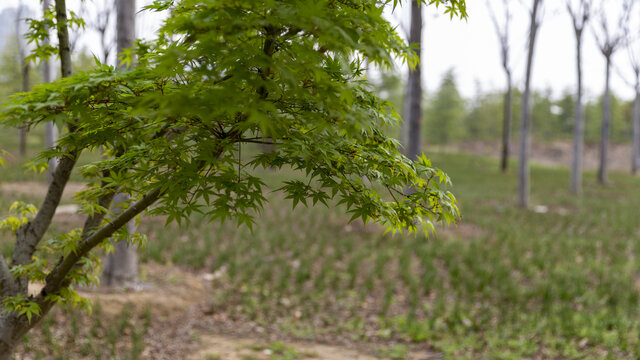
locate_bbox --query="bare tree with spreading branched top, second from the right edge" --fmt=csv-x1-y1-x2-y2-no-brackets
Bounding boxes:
594,0,633,184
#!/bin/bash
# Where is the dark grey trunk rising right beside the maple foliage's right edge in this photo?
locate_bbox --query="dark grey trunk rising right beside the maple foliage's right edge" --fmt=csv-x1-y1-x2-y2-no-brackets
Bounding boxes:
405,0,422,160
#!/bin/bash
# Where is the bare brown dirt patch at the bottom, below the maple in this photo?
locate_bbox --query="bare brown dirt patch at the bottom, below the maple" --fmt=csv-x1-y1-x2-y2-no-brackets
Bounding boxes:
74,264,440,360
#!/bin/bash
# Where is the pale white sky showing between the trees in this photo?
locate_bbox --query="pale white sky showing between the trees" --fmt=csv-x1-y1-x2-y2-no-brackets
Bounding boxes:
0,0,640,99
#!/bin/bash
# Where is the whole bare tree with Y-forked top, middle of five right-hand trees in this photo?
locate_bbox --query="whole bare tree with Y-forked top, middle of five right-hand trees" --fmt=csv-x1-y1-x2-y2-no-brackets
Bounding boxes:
567,0,592,195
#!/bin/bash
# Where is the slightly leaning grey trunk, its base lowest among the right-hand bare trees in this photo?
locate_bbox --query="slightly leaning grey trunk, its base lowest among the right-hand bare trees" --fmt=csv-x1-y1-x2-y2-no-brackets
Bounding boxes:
518,0,542,208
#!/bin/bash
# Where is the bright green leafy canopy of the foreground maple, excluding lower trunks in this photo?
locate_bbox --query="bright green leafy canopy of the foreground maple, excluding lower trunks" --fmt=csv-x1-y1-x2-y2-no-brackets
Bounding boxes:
4,0,457,235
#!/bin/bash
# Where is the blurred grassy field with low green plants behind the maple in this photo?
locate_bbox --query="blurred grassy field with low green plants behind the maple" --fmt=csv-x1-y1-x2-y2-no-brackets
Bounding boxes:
0,126,640,359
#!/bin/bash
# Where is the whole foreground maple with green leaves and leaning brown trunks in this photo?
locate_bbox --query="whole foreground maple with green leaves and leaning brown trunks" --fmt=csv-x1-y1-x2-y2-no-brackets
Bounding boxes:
0,0,466,360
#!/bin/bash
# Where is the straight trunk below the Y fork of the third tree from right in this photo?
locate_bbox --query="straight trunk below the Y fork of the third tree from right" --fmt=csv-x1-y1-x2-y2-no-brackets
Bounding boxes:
571,30,584,195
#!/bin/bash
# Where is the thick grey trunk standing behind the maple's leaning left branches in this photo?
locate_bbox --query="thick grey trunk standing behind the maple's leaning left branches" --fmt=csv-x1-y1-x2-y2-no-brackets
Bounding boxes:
102,0,138,287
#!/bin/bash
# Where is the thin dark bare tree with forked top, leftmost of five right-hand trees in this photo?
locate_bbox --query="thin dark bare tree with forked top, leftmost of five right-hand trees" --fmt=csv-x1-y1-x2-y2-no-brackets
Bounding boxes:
487,0,513,172
